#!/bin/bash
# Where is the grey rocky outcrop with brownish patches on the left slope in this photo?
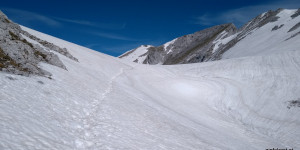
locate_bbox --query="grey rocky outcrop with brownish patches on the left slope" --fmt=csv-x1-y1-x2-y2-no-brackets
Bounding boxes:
0,11,78,77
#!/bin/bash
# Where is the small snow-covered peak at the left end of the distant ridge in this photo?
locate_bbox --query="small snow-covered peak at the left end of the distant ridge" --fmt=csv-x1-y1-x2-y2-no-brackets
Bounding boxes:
119,45,153,64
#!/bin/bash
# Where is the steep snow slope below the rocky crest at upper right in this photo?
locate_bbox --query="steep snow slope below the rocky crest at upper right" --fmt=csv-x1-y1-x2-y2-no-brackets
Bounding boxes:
222,9,300,59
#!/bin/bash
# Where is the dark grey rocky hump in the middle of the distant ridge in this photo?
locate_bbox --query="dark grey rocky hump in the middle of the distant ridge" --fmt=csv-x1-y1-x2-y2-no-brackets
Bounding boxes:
144,24,237,65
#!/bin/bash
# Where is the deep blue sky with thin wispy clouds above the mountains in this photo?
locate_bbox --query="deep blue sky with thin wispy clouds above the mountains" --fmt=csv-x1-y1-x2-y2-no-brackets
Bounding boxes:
0,0,300,56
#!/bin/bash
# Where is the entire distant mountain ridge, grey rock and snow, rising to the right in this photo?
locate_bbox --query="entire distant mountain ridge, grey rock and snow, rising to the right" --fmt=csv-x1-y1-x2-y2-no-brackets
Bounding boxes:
119,9,300,65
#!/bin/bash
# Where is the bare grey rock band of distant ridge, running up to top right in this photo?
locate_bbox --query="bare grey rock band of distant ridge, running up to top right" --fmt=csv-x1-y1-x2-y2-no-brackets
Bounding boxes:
120,9,283,65
